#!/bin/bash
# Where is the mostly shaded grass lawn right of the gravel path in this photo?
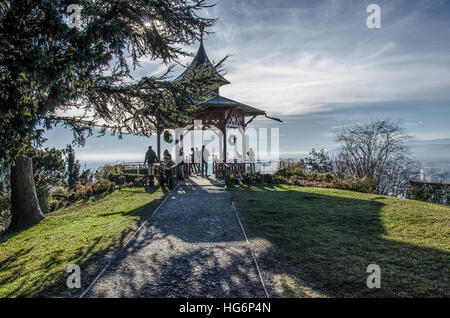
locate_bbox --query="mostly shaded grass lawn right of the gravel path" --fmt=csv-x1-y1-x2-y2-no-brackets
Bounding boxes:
231,185,450,297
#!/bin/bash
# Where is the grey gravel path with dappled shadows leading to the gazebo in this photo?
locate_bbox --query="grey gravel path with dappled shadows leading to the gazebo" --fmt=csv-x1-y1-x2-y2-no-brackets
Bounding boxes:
86,179,265,297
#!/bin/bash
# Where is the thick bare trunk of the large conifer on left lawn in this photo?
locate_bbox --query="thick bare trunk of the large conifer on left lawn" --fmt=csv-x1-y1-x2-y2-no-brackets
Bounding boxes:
9,157,45,230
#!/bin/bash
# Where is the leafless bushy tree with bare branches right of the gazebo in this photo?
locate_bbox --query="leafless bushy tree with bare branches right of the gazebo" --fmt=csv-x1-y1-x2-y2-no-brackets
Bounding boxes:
335,120,415,196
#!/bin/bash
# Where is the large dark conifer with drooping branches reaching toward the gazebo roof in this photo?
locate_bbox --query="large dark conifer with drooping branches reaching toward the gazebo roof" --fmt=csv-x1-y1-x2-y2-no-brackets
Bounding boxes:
0,0,220,229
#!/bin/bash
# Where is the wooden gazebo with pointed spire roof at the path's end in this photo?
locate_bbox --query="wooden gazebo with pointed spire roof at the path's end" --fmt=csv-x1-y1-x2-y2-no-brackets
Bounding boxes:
157,39,280,178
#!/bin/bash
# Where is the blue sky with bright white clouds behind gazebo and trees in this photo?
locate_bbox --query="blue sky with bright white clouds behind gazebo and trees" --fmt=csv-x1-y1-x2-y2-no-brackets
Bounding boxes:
46,0,450,168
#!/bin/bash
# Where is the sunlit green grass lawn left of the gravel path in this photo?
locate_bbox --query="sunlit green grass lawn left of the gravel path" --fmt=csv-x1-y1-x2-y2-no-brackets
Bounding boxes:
0,188,163,297
